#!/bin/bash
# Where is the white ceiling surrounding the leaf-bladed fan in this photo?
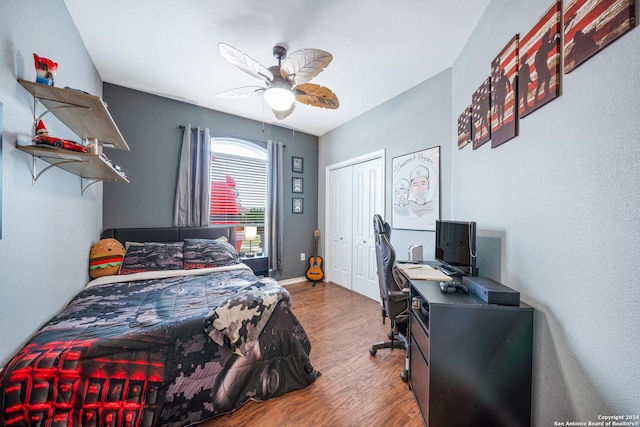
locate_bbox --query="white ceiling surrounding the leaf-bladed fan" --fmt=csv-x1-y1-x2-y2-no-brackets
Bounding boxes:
64,0,490,136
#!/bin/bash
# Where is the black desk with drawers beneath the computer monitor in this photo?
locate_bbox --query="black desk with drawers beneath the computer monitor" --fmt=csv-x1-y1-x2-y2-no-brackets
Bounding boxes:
409,280,533,427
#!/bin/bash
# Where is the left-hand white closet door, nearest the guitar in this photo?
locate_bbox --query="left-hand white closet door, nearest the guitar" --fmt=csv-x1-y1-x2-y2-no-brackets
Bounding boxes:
325,167,353,289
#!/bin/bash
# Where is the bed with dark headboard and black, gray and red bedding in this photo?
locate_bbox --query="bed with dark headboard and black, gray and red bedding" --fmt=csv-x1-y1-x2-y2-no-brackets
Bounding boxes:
0,227,319,427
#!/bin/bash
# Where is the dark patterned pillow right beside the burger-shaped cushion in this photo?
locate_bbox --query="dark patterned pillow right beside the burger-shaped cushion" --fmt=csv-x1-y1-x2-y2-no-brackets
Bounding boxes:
118,242,184,274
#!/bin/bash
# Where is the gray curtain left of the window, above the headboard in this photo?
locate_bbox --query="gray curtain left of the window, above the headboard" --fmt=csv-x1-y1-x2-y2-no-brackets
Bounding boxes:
173,125,211,227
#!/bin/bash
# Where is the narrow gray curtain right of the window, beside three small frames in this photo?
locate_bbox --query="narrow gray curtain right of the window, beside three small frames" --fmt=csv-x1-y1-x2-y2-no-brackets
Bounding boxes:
265,141,284,273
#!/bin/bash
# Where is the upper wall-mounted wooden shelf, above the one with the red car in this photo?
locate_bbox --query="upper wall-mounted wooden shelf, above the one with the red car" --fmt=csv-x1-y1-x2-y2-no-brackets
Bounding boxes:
18,80,129,150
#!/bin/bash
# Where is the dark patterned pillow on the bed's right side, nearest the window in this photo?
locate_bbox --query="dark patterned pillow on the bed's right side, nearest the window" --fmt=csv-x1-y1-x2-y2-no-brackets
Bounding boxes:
184,239,240,270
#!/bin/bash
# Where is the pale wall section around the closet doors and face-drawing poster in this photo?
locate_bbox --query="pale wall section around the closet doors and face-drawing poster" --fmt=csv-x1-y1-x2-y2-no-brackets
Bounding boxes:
318,70,452,259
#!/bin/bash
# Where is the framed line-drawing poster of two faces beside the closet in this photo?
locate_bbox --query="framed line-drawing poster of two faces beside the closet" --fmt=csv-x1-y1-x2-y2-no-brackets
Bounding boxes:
391,146,440,231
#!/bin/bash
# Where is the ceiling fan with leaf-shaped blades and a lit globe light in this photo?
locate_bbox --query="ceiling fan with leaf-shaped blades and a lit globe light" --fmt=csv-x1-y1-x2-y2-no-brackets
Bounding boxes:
218,43,340,120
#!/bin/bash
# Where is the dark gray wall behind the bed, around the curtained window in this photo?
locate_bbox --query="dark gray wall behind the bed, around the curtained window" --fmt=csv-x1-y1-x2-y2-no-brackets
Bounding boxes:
103,84,318,279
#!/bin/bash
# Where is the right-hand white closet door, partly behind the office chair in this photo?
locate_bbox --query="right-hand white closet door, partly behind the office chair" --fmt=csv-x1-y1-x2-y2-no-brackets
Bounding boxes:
352,158,384,300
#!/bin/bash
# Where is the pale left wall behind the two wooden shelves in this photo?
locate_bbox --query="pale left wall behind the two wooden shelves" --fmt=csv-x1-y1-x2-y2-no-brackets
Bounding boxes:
0,0,102,365
